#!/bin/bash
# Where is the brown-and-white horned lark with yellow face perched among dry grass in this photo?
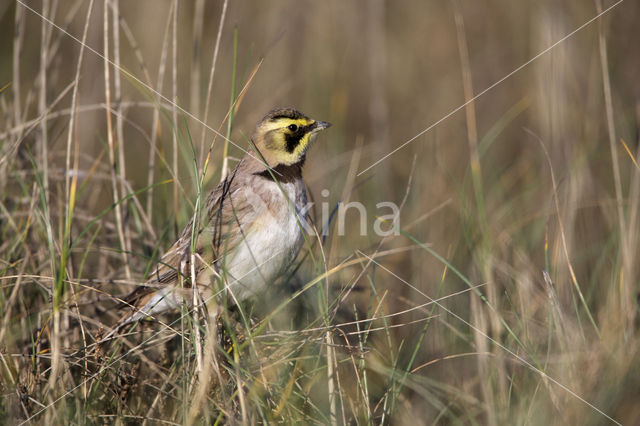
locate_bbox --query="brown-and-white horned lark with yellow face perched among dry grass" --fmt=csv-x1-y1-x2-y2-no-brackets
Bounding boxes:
102,108,331,341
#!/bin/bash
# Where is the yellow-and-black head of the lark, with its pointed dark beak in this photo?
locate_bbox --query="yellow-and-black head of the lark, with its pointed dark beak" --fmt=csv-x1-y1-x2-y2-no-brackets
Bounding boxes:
251,108,331,167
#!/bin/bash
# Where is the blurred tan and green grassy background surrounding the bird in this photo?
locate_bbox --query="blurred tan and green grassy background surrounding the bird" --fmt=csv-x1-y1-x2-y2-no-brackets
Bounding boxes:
0,0,640,424
